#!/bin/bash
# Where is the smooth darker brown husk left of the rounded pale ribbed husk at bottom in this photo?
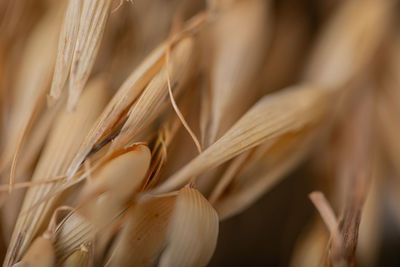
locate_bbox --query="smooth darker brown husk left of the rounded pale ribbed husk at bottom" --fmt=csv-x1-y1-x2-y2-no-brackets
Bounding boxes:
110,195,176,267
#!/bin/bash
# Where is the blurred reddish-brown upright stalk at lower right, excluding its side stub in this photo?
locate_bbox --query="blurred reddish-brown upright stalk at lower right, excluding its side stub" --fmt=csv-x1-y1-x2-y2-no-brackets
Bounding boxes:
334,88,377,266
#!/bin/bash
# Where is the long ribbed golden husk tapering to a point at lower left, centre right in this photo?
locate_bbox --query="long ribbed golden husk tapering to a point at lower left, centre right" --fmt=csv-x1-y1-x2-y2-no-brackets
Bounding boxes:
154,86,329,195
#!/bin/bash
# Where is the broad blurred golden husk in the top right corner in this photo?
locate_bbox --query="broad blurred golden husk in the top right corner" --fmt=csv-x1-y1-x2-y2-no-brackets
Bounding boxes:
304,0,394,89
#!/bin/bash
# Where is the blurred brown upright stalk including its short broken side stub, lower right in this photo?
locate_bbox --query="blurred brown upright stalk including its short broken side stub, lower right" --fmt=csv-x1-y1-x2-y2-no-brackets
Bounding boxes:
310,88,376,266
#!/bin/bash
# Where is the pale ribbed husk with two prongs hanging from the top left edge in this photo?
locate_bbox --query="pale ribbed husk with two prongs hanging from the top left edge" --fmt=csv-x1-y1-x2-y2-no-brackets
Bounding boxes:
50,0,112,110
